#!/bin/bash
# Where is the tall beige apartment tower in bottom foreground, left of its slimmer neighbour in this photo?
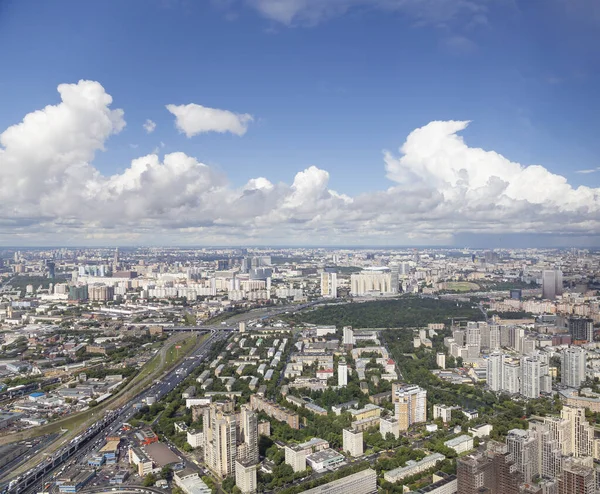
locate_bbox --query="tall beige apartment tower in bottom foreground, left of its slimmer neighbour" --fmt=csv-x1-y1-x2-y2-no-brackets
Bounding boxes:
202,402,237,478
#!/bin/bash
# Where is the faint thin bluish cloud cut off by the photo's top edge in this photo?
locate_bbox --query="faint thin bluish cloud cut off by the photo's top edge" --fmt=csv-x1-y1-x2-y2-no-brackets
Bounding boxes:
239,0,487,26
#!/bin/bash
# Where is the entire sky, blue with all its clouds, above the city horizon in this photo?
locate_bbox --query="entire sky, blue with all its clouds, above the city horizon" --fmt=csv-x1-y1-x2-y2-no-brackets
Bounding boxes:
0,0,600,247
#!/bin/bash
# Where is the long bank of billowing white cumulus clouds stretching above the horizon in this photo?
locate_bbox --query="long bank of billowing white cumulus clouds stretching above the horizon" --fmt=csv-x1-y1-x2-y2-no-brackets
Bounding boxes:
0,81,600,245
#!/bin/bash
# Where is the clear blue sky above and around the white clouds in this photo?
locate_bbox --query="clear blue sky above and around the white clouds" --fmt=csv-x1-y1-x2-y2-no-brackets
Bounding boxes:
0,0,600,244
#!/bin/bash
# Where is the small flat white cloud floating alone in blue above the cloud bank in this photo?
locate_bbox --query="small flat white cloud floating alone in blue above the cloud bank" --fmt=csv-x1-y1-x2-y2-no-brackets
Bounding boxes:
167,103,254,137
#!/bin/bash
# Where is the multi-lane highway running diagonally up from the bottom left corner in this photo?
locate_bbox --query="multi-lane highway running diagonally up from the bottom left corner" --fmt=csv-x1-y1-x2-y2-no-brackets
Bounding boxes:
2,330,229,494
